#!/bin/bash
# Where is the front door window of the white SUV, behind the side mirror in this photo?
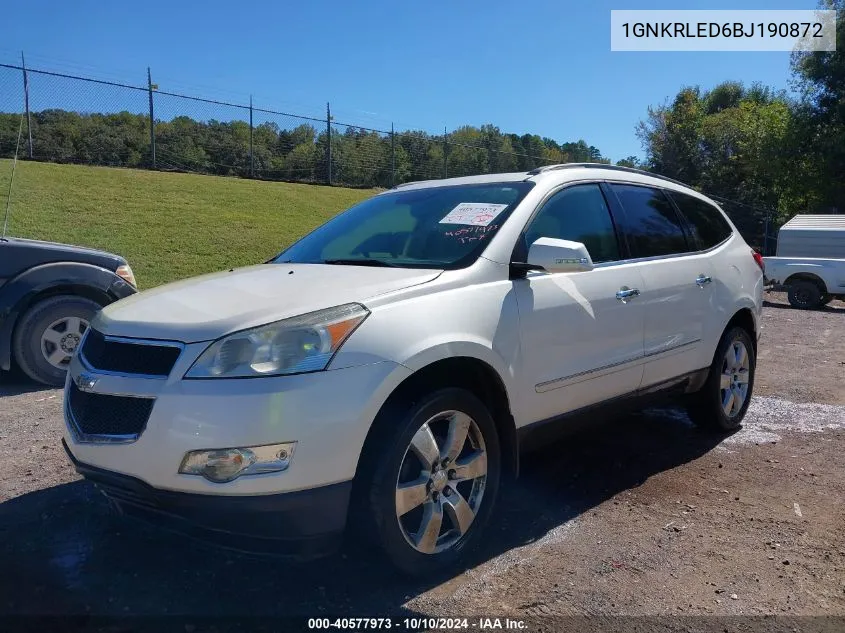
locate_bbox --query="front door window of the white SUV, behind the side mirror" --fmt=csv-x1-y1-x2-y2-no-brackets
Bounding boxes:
525,184,619,263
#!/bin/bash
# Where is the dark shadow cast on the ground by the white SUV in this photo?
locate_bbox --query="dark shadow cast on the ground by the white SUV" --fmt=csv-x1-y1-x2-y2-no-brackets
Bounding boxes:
0,409,720,630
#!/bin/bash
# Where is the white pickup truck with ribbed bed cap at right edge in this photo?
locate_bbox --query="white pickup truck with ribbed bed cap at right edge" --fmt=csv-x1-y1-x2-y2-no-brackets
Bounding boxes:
763,215,845,310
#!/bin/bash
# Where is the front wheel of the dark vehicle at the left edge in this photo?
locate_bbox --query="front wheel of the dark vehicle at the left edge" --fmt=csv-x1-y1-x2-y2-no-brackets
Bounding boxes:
12,295,101,387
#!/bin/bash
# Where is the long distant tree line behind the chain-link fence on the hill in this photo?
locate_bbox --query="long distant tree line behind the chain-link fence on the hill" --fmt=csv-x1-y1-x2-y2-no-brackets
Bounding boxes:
0,110,607,187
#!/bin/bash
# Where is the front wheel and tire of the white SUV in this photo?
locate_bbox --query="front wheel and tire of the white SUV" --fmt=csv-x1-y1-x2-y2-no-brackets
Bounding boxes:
357,388,502,576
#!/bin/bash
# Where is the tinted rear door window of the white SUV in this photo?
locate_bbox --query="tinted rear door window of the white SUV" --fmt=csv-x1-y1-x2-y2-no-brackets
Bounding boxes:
611,185,692,258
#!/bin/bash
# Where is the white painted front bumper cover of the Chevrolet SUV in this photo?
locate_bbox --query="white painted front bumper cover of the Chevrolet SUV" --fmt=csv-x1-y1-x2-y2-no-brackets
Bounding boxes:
64,354,410,497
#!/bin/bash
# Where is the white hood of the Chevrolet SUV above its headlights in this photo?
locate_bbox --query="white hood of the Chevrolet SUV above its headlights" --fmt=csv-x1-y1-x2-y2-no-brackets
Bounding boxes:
93,264,442,343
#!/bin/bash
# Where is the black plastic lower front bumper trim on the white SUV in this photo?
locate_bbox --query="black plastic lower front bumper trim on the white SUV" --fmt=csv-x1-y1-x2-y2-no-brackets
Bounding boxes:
62,440,352,559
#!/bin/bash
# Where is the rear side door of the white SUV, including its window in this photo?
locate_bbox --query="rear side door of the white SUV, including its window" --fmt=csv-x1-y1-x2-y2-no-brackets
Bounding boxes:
609,183,712,387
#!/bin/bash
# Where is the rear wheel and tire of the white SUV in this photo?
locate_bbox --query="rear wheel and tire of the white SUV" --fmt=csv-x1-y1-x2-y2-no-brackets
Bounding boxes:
687,327,757,433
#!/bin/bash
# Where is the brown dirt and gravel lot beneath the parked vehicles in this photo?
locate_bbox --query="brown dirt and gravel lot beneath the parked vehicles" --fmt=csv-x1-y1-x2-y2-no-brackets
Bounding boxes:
0,295,845,633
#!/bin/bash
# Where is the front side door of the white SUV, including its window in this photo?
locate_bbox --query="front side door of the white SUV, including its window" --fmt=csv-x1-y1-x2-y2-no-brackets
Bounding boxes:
514,183,645,423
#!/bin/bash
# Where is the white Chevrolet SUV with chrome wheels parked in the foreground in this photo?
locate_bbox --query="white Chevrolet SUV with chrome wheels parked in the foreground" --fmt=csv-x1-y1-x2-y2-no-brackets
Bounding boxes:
65,164,763,574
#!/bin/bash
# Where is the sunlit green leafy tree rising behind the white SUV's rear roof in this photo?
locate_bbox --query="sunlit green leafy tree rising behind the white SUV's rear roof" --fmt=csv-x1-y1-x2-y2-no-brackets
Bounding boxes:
640,82,807,245
